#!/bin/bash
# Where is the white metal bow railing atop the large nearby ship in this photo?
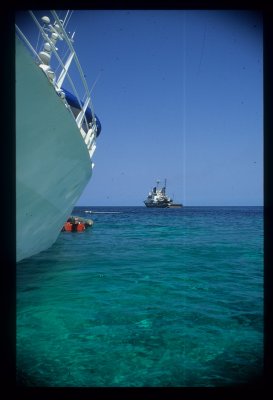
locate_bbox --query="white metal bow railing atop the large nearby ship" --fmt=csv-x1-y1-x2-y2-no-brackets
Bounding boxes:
16,11,97,157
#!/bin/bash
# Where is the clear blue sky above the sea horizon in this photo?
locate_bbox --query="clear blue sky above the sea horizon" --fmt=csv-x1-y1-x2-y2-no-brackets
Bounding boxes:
16,10,263,206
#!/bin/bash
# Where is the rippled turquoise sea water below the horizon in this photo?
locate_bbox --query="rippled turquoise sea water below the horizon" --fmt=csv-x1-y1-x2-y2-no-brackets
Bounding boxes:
16,207,263,387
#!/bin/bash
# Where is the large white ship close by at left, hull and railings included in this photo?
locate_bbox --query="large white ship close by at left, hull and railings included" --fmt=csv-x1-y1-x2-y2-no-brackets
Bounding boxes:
15,11,101,261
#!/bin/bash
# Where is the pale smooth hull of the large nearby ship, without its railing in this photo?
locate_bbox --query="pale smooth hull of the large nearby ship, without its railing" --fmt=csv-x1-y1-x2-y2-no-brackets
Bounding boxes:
16,38,92,261
